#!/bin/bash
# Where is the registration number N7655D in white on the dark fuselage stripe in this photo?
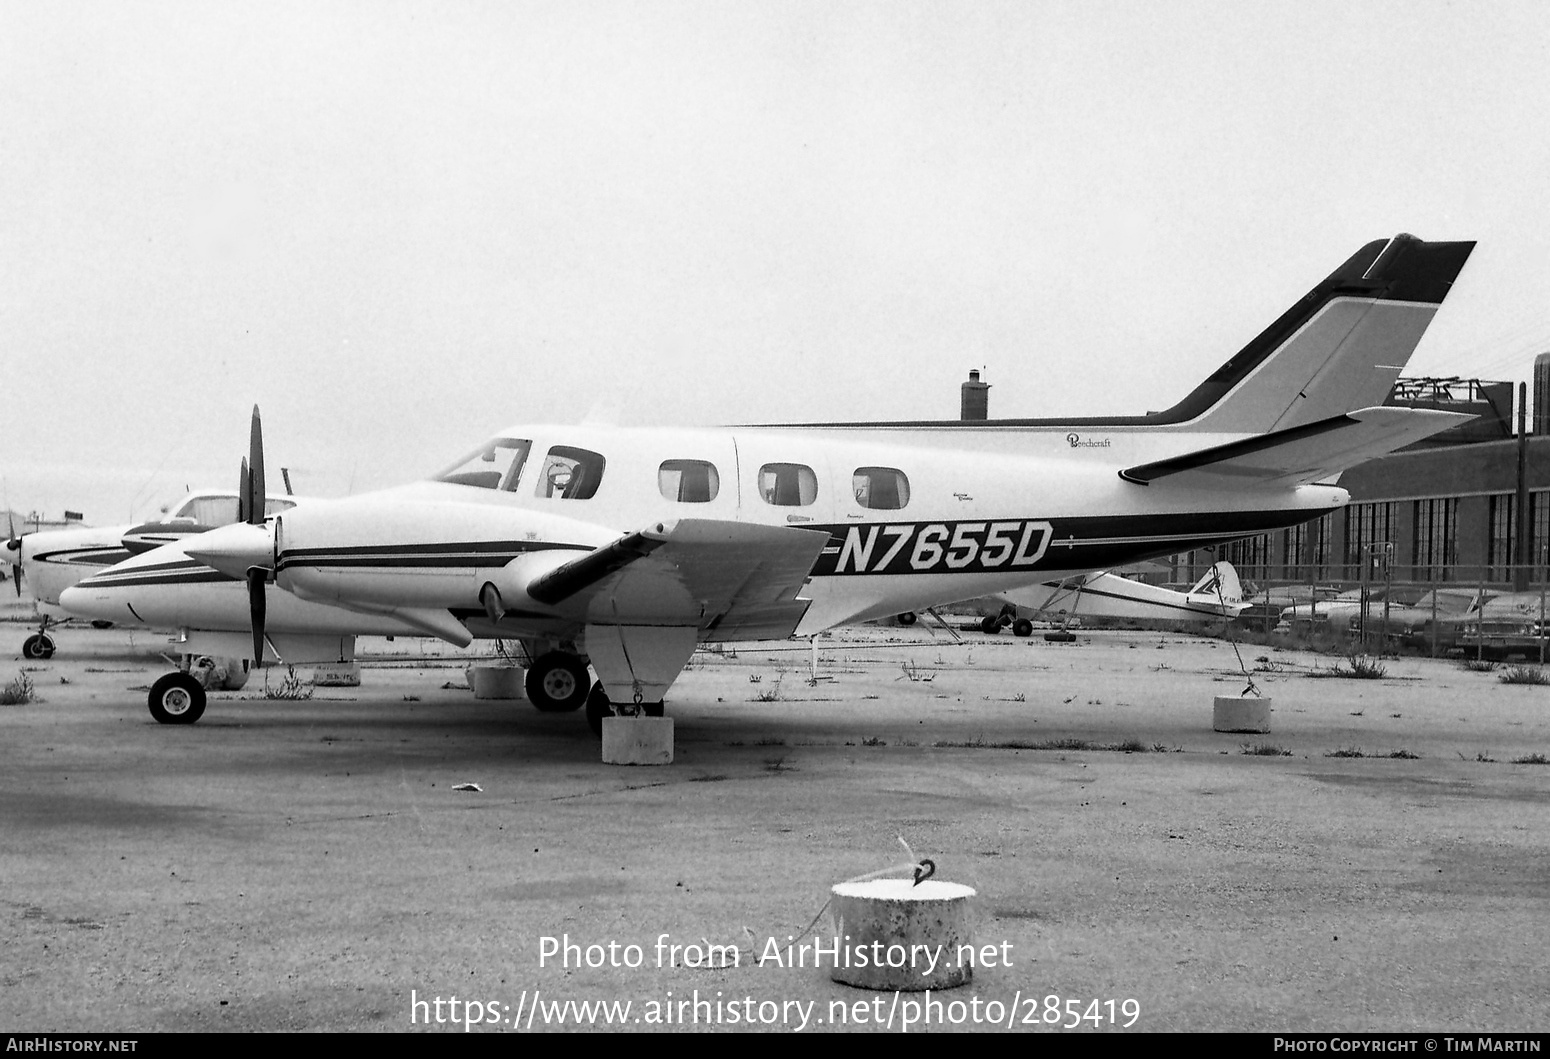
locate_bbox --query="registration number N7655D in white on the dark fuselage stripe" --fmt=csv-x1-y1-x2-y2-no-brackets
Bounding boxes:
812,519,1054,574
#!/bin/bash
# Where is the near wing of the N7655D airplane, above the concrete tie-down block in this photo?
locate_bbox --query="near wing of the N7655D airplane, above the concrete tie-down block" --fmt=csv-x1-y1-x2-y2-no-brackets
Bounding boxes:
527,518,829,639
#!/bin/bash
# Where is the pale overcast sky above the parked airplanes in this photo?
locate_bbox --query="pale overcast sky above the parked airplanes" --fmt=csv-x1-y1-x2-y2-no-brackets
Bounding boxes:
0,0,1550,523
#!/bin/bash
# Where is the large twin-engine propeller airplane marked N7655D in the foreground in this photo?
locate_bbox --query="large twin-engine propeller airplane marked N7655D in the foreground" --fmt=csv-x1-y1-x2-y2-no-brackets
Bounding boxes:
62,236,1474,727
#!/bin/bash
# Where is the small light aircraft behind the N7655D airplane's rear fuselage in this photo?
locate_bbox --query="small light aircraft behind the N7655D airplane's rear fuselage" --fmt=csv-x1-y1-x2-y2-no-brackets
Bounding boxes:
980,560,1249,636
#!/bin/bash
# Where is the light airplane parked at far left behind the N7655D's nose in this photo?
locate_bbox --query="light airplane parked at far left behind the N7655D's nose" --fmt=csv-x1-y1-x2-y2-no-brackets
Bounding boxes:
5,488,296,659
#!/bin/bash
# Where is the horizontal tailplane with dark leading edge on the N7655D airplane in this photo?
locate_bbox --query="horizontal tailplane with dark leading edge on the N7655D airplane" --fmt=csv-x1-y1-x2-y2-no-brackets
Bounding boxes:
1119,406,1474,485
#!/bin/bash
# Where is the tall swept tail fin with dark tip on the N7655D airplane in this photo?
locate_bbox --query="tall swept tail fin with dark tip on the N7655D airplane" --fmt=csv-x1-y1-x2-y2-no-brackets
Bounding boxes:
1165,236,1474,434
